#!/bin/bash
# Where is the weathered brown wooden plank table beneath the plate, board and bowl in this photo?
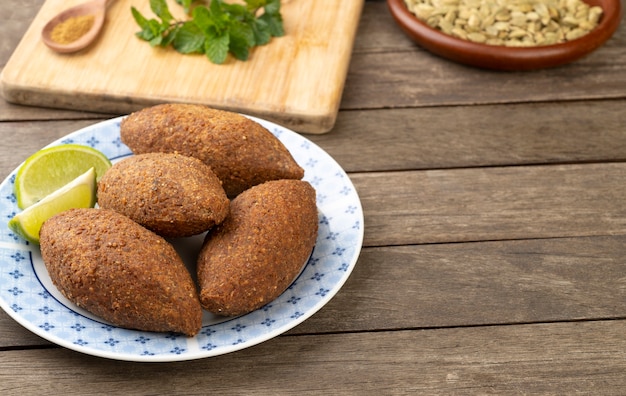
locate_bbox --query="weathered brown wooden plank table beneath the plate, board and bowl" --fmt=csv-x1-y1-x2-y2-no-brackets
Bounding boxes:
0,0,626,395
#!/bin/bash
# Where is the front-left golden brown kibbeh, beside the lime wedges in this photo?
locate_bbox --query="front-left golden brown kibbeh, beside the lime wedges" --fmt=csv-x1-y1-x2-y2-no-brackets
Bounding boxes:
40,208,202,336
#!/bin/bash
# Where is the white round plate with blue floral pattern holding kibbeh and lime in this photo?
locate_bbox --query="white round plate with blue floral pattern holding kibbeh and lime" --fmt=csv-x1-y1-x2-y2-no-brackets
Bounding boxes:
0,117,363,362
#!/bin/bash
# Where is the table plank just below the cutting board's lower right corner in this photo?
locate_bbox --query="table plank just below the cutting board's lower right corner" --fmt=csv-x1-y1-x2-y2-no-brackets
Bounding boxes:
307,99,626,172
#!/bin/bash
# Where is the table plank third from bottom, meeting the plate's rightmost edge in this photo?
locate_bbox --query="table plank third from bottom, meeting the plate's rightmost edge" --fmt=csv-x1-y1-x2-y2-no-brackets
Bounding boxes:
350,163,626,246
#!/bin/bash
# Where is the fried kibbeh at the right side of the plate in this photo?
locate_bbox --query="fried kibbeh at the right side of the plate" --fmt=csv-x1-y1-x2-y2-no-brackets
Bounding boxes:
197,180,318,316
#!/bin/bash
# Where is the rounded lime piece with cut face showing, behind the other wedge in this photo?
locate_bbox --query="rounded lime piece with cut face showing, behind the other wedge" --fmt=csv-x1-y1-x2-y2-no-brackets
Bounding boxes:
15,144,111,209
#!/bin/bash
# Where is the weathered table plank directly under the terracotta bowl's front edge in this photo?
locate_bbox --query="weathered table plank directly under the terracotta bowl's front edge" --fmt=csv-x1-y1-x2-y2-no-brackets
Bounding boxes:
341,47,626,110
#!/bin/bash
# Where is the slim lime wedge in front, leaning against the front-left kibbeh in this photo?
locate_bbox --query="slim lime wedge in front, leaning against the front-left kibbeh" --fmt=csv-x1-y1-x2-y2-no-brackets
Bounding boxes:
9,168,97,244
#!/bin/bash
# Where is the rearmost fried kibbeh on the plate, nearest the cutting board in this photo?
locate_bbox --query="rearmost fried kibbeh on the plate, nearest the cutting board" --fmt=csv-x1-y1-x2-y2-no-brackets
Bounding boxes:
120,104,304,198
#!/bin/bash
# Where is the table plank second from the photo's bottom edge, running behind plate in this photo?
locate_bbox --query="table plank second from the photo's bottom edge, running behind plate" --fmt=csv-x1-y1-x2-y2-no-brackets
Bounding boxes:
0,235,626,349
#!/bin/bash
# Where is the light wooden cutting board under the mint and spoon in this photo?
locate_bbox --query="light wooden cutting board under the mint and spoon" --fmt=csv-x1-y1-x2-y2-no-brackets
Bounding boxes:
0,0,364,133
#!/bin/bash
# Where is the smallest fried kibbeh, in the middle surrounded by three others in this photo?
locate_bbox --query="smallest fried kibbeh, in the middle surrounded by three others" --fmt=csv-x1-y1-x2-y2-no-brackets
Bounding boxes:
98,153,230,237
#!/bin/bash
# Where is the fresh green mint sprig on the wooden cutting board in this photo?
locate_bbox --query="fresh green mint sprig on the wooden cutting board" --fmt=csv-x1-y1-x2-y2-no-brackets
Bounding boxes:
131,0,285,64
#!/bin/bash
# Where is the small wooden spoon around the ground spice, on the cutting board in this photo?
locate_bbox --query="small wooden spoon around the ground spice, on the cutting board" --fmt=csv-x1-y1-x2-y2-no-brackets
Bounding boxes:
41,0,113,53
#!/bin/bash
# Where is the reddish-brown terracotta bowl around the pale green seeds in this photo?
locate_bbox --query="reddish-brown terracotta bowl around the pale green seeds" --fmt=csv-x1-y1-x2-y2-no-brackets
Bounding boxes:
387,0,622,71
